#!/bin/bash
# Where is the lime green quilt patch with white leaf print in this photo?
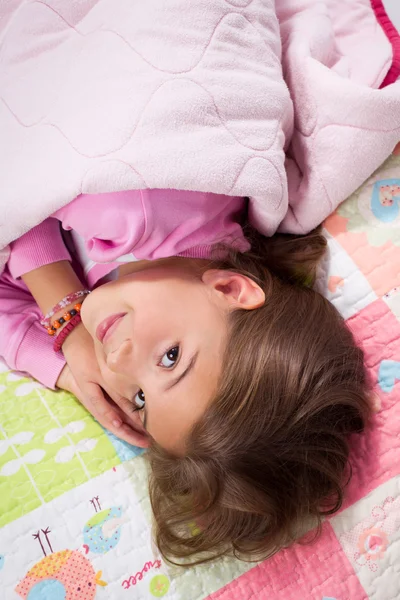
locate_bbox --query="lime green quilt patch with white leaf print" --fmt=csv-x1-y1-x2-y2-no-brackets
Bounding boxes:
0,372,121,527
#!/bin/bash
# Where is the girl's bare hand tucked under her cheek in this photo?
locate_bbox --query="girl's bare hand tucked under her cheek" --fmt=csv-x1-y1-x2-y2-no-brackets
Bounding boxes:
57,324,149,448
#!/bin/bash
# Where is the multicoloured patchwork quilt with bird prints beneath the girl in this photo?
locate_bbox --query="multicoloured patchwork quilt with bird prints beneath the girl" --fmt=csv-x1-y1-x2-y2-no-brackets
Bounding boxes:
0,146,400,600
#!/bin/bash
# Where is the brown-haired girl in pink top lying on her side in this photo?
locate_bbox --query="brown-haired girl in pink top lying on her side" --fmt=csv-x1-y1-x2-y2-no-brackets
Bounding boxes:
0,190,370,562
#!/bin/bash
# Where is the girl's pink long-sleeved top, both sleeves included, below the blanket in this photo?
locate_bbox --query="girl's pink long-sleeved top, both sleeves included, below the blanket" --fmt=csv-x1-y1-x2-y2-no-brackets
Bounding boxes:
0,190,249,388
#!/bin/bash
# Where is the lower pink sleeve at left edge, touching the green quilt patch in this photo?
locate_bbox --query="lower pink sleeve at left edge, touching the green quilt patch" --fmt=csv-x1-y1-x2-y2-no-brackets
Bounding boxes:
0,268,65,389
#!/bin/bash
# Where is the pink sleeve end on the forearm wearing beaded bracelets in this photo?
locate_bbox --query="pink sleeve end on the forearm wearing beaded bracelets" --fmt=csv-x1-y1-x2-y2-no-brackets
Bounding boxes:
8,217,71,279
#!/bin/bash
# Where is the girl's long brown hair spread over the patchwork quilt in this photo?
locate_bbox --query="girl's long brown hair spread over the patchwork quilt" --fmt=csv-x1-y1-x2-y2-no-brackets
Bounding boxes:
148,227,370,564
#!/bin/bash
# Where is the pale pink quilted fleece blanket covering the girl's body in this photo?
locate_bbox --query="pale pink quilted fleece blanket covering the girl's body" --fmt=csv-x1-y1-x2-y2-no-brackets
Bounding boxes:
0,0,400,258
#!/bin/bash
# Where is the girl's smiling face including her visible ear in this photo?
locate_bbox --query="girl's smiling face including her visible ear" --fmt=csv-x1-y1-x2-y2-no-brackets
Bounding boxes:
82,259,264,452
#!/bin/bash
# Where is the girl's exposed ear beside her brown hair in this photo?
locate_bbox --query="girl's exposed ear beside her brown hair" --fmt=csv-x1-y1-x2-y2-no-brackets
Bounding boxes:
202,269,265,310
